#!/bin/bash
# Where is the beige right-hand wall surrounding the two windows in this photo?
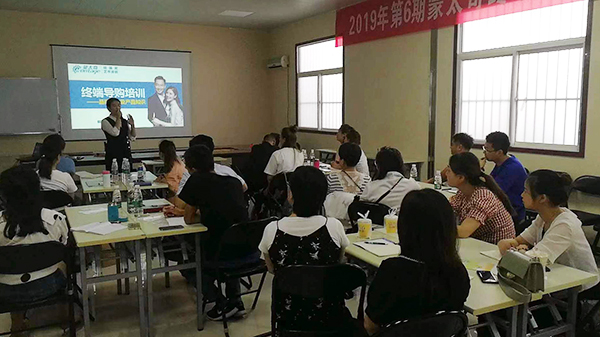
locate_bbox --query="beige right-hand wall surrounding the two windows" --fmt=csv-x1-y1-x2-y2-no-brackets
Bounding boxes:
269,5,600,177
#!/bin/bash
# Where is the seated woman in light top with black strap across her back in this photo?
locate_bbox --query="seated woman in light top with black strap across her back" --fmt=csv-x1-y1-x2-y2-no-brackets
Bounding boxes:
361,147,421,209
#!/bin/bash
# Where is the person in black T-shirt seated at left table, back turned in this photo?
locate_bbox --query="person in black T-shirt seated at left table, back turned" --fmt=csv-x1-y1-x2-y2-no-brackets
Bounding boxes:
179,145,250,320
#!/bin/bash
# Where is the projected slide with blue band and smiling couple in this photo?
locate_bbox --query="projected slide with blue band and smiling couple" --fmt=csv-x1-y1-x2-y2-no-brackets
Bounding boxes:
67,63,187,130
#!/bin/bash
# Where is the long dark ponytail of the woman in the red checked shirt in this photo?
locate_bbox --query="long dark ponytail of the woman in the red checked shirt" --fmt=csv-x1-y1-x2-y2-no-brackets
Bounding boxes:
450,152,517,217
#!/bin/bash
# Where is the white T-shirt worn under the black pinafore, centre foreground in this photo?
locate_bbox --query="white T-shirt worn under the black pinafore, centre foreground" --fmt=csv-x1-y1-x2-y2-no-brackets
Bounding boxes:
258,215,350,258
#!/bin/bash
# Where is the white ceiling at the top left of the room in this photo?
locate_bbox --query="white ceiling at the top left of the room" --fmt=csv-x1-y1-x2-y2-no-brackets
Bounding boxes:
0,0,362,29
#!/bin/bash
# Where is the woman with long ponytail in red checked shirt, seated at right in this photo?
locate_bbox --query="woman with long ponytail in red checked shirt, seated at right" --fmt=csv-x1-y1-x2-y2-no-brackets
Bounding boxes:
448,152,515,244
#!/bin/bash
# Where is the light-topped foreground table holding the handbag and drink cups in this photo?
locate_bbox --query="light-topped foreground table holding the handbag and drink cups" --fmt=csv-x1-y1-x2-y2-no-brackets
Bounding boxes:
346,234,596,337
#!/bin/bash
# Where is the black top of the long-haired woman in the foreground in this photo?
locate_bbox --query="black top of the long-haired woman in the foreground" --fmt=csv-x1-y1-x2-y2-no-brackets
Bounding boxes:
366,256,471,325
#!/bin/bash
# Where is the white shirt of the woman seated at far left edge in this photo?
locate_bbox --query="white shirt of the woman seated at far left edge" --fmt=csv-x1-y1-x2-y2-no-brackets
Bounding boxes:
0,208,69,285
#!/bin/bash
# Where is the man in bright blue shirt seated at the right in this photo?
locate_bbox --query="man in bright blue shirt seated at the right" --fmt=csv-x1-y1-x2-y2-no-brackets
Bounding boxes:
481,132,527,225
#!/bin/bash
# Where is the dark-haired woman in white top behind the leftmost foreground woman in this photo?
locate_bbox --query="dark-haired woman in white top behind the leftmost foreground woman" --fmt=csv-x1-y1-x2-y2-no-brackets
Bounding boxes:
37,137,77,197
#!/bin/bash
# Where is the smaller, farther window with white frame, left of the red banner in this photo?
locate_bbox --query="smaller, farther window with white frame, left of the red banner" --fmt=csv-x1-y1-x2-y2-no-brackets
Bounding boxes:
294,35,346,135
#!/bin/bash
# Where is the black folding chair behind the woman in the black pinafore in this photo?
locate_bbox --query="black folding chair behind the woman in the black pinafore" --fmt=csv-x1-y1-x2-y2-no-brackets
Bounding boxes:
271,264,367,336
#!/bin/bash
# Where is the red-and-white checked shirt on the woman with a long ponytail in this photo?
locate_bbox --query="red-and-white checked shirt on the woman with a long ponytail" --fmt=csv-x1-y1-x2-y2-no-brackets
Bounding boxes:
450,187,515,244
